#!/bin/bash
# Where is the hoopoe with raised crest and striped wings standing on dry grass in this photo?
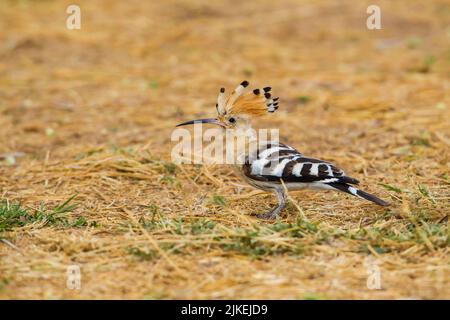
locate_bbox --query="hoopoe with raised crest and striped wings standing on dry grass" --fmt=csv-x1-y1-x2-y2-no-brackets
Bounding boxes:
177,81,389,219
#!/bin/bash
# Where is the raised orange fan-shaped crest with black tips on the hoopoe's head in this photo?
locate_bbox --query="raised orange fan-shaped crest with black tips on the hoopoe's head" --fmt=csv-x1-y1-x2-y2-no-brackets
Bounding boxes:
216,81,278,116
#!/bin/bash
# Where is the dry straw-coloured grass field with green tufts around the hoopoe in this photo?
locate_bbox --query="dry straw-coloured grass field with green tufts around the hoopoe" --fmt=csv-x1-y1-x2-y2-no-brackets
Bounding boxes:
0,0,450,299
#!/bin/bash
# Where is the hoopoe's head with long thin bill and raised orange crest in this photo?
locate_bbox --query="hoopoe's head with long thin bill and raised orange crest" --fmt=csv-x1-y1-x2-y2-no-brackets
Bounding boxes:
177,81,278,129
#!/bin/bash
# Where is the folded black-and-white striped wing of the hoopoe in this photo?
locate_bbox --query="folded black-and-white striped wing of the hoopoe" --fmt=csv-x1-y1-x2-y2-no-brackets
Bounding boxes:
243,144,358,184
